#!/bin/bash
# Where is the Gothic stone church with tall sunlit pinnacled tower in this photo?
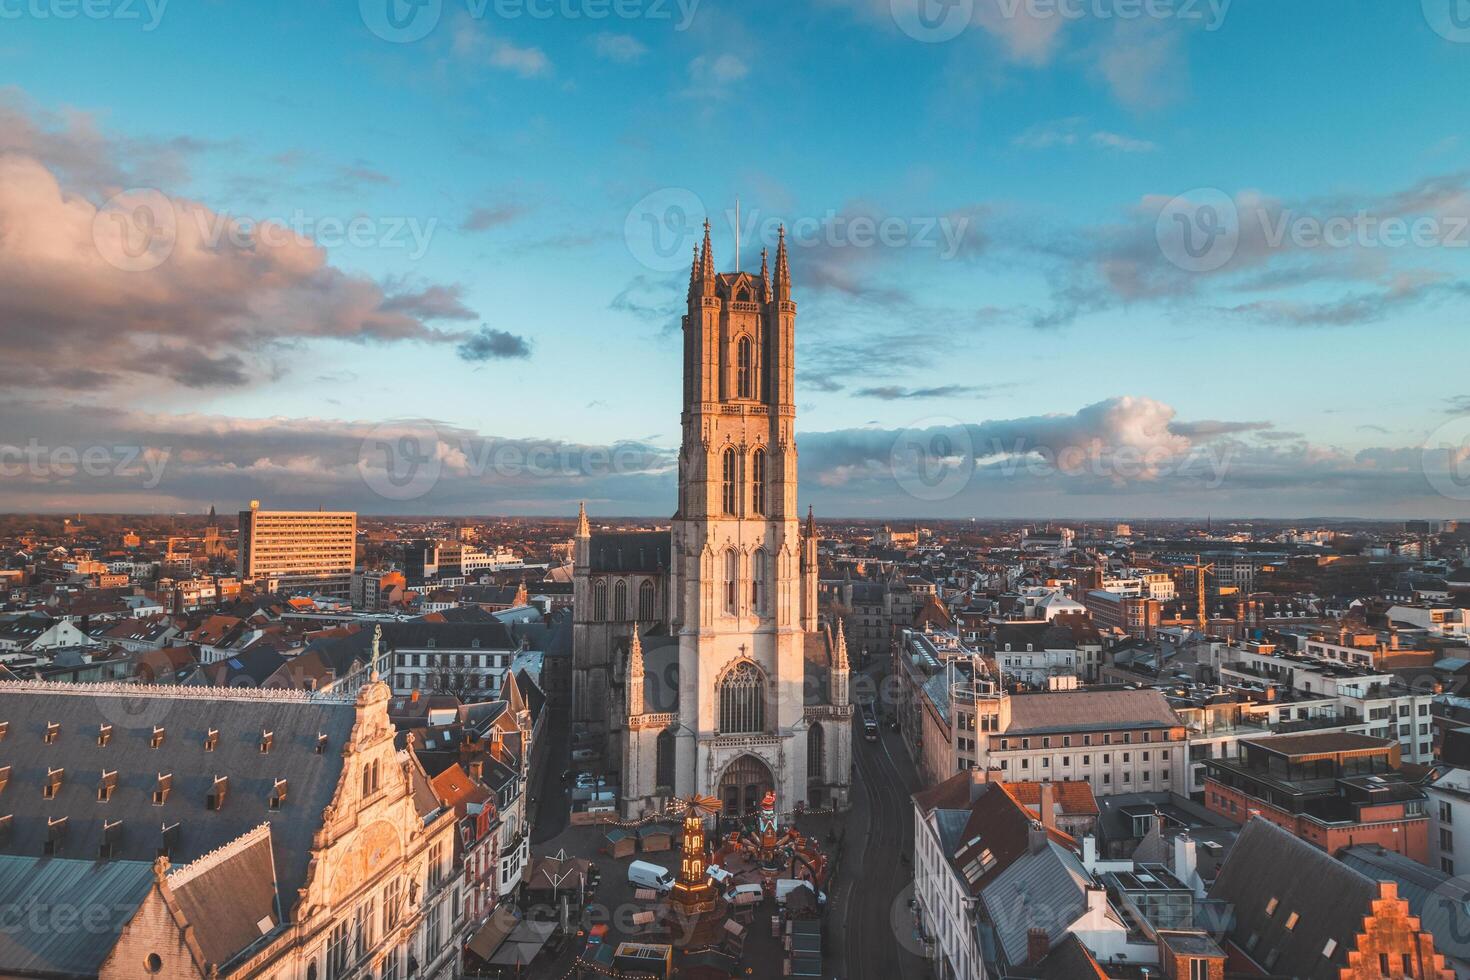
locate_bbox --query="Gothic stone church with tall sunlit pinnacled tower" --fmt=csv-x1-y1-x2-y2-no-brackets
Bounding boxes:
573,223,853,818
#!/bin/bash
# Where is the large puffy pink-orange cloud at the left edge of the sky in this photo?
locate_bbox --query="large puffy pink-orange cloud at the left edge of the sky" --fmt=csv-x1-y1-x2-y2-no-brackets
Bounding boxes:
0,153,475,388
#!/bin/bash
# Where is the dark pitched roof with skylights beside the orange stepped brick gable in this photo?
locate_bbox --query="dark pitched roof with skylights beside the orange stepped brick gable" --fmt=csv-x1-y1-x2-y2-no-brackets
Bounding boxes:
1210,817,1379,980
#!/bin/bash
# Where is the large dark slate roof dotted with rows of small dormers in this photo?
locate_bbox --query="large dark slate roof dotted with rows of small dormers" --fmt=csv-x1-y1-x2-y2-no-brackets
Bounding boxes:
0,682,357,909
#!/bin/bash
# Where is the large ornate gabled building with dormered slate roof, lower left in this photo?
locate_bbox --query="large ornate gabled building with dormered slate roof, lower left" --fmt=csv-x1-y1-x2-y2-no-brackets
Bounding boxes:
0,680,463,980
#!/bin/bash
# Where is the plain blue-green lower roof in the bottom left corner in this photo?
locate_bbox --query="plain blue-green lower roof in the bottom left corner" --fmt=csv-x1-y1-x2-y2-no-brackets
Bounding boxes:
0,852,153,977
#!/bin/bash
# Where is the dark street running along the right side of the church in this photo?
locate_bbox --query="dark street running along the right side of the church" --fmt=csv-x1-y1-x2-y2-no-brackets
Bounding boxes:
831,671,928,980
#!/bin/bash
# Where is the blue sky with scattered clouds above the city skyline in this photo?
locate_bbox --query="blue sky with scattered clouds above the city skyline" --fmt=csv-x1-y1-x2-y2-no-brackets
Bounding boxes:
0,0,1470,517
